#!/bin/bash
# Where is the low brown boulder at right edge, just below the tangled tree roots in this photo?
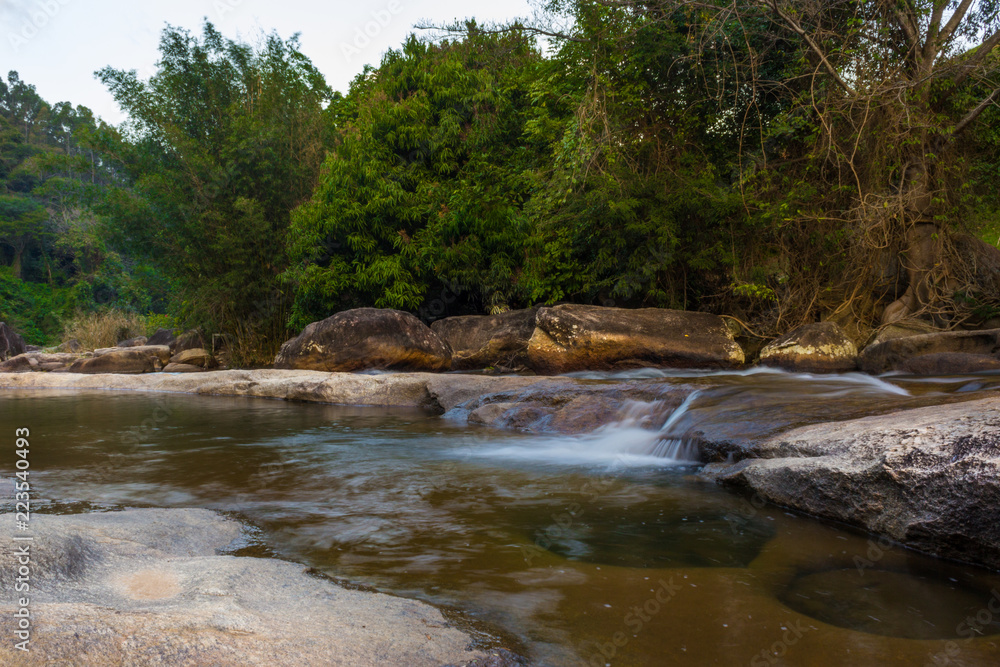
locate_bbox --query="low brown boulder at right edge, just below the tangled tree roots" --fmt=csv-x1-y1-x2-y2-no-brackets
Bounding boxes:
859,329,1000,373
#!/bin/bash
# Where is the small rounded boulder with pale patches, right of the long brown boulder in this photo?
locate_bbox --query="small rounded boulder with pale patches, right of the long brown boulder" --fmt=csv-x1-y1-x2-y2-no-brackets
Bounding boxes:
760,322,858,373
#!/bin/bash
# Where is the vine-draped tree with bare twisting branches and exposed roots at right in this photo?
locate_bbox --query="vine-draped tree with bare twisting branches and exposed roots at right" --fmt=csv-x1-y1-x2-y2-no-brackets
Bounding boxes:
580,0,1000,325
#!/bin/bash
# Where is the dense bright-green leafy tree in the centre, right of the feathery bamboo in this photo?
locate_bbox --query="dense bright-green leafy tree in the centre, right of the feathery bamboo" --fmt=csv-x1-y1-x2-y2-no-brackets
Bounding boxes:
287,25,539,328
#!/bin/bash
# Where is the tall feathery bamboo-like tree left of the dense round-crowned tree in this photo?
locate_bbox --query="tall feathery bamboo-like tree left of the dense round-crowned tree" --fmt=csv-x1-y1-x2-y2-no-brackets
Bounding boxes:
97,23,331,363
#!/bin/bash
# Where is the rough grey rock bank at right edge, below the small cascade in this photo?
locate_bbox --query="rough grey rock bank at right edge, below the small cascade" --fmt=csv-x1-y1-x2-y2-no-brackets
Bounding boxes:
705,397,1000,568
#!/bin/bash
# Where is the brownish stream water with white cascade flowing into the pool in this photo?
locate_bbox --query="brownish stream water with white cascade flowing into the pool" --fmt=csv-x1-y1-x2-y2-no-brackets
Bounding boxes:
0,371,1000,667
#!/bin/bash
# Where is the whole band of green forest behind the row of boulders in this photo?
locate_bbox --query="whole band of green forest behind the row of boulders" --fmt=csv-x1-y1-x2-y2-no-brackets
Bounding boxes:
0,0,1000,364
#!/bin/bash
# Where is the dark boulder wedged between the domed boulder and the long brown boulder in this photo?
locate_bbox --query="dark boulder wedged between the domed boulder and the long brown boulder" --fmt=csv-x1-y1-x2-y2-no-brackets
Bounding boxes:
431,308,538,371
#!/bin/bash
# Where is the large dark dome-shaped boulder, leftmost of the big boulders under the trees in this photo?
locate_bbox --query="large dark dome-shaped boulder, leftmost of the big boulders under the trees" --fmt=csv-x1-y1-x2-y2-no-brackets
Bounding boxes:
274,308,451,372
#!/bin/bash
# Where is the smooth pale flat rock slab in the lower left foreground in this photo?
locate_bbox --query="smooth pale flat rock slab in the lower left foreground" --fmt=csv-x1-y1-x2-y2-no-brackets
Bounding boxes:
0,509,489,667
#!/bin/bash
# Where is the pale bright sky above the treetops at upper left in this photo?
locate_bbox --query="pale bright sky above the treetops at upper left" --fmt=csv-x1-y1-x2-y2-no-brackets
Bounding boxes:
0,0,532,124
